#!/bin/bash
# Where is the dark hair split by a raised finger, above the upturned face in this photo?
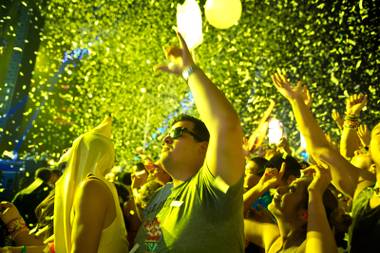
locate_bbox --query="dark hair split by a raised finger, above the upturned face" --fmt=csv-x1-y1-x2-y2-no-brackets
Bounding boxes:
266,154,302,181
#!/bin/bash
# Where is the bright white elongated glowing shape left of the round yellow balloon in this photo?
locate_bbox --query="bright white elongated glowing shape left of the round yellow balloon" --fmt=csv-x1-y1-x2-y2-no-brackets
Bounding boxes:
177,0,203,49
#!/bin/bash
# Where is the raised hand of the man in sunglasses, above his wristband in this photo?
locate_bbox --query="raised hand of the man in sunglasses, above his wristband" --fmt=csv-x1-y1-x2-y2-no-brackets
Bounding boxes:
154,32,194,75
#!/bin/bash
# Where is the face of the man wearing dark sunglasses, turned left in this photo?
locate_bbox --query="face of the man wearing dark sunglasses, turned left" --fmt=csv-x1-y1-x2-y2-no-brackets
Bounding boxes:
160,121,204,170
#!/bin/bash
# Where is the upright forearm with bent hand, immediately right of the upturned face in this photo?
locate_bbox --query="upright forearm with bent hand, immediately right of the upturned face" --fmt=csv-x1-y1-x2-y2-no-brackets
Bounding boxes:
305,166,338,253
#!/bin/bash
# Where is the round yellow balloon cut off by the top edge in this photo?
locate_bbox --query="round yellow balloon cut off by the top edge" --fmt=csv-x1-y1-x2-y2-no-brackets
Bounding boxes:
205,0,242,29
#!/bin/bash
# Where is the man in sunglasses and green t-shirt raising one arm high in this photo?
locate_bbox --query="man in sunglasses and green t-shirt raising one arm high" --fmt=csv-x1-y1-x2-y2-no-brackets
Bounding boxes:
132,34,244,253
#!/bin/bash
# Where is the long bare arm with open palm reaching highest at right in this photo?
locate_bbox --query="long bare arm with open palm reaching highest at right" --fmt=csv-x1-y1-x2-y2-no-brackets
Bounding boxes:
272,73,375,197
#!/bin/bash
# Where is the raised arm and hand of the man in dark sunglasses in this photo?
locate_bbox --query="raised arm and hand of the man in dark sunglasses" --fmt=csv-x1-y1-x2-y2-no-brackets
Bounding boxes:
158,33,244,185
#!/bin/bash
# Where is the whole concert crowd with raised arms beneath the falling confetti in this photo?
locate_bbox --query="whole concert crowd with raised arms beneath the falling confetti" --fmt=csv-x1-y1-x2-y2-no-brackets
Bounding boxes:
0,33,380,253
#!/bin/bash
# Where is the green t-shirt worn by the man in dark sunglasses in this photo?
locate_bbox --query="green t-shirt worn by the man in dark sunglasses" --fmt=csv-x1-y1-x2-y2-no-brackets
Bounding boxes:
135,166,244,253
